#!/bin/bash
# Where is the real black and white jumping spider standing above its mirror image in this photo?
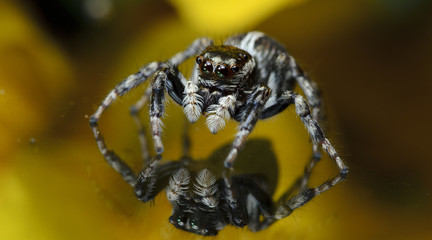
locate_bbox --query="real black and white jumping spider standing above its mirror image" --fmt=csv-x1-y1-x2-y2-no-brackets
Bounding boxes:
90,32,348,188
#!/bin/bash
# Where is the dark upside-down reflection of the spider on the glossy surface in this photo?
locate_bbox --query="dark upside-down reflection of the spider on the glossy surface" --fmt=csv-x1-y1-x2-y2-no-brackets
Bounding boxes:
105,124,341,236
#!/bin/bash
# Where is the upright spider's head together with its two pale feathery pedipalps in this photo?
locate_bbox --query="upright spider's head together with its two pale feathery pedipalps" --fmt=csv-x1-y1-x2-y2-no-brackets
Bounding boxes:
182,45,255,133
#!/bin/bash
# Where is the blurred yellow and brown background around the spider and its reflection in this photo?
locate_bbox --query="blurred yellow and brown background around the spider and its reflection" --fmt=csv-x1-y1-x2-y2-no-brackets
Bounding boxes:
0,0,432,239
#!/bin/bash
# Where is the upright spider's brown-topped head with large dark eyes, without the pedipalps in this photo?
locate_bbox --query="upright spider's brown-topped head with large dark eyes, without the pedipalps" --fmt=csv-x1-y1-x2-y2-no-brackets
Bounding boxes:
196,45,255,88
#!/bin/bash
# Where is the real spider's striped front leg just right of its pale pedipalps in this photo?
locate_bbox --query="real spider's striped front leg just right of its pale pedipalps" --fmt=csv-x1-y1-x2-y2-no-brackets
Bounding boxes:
224,85,271,170
